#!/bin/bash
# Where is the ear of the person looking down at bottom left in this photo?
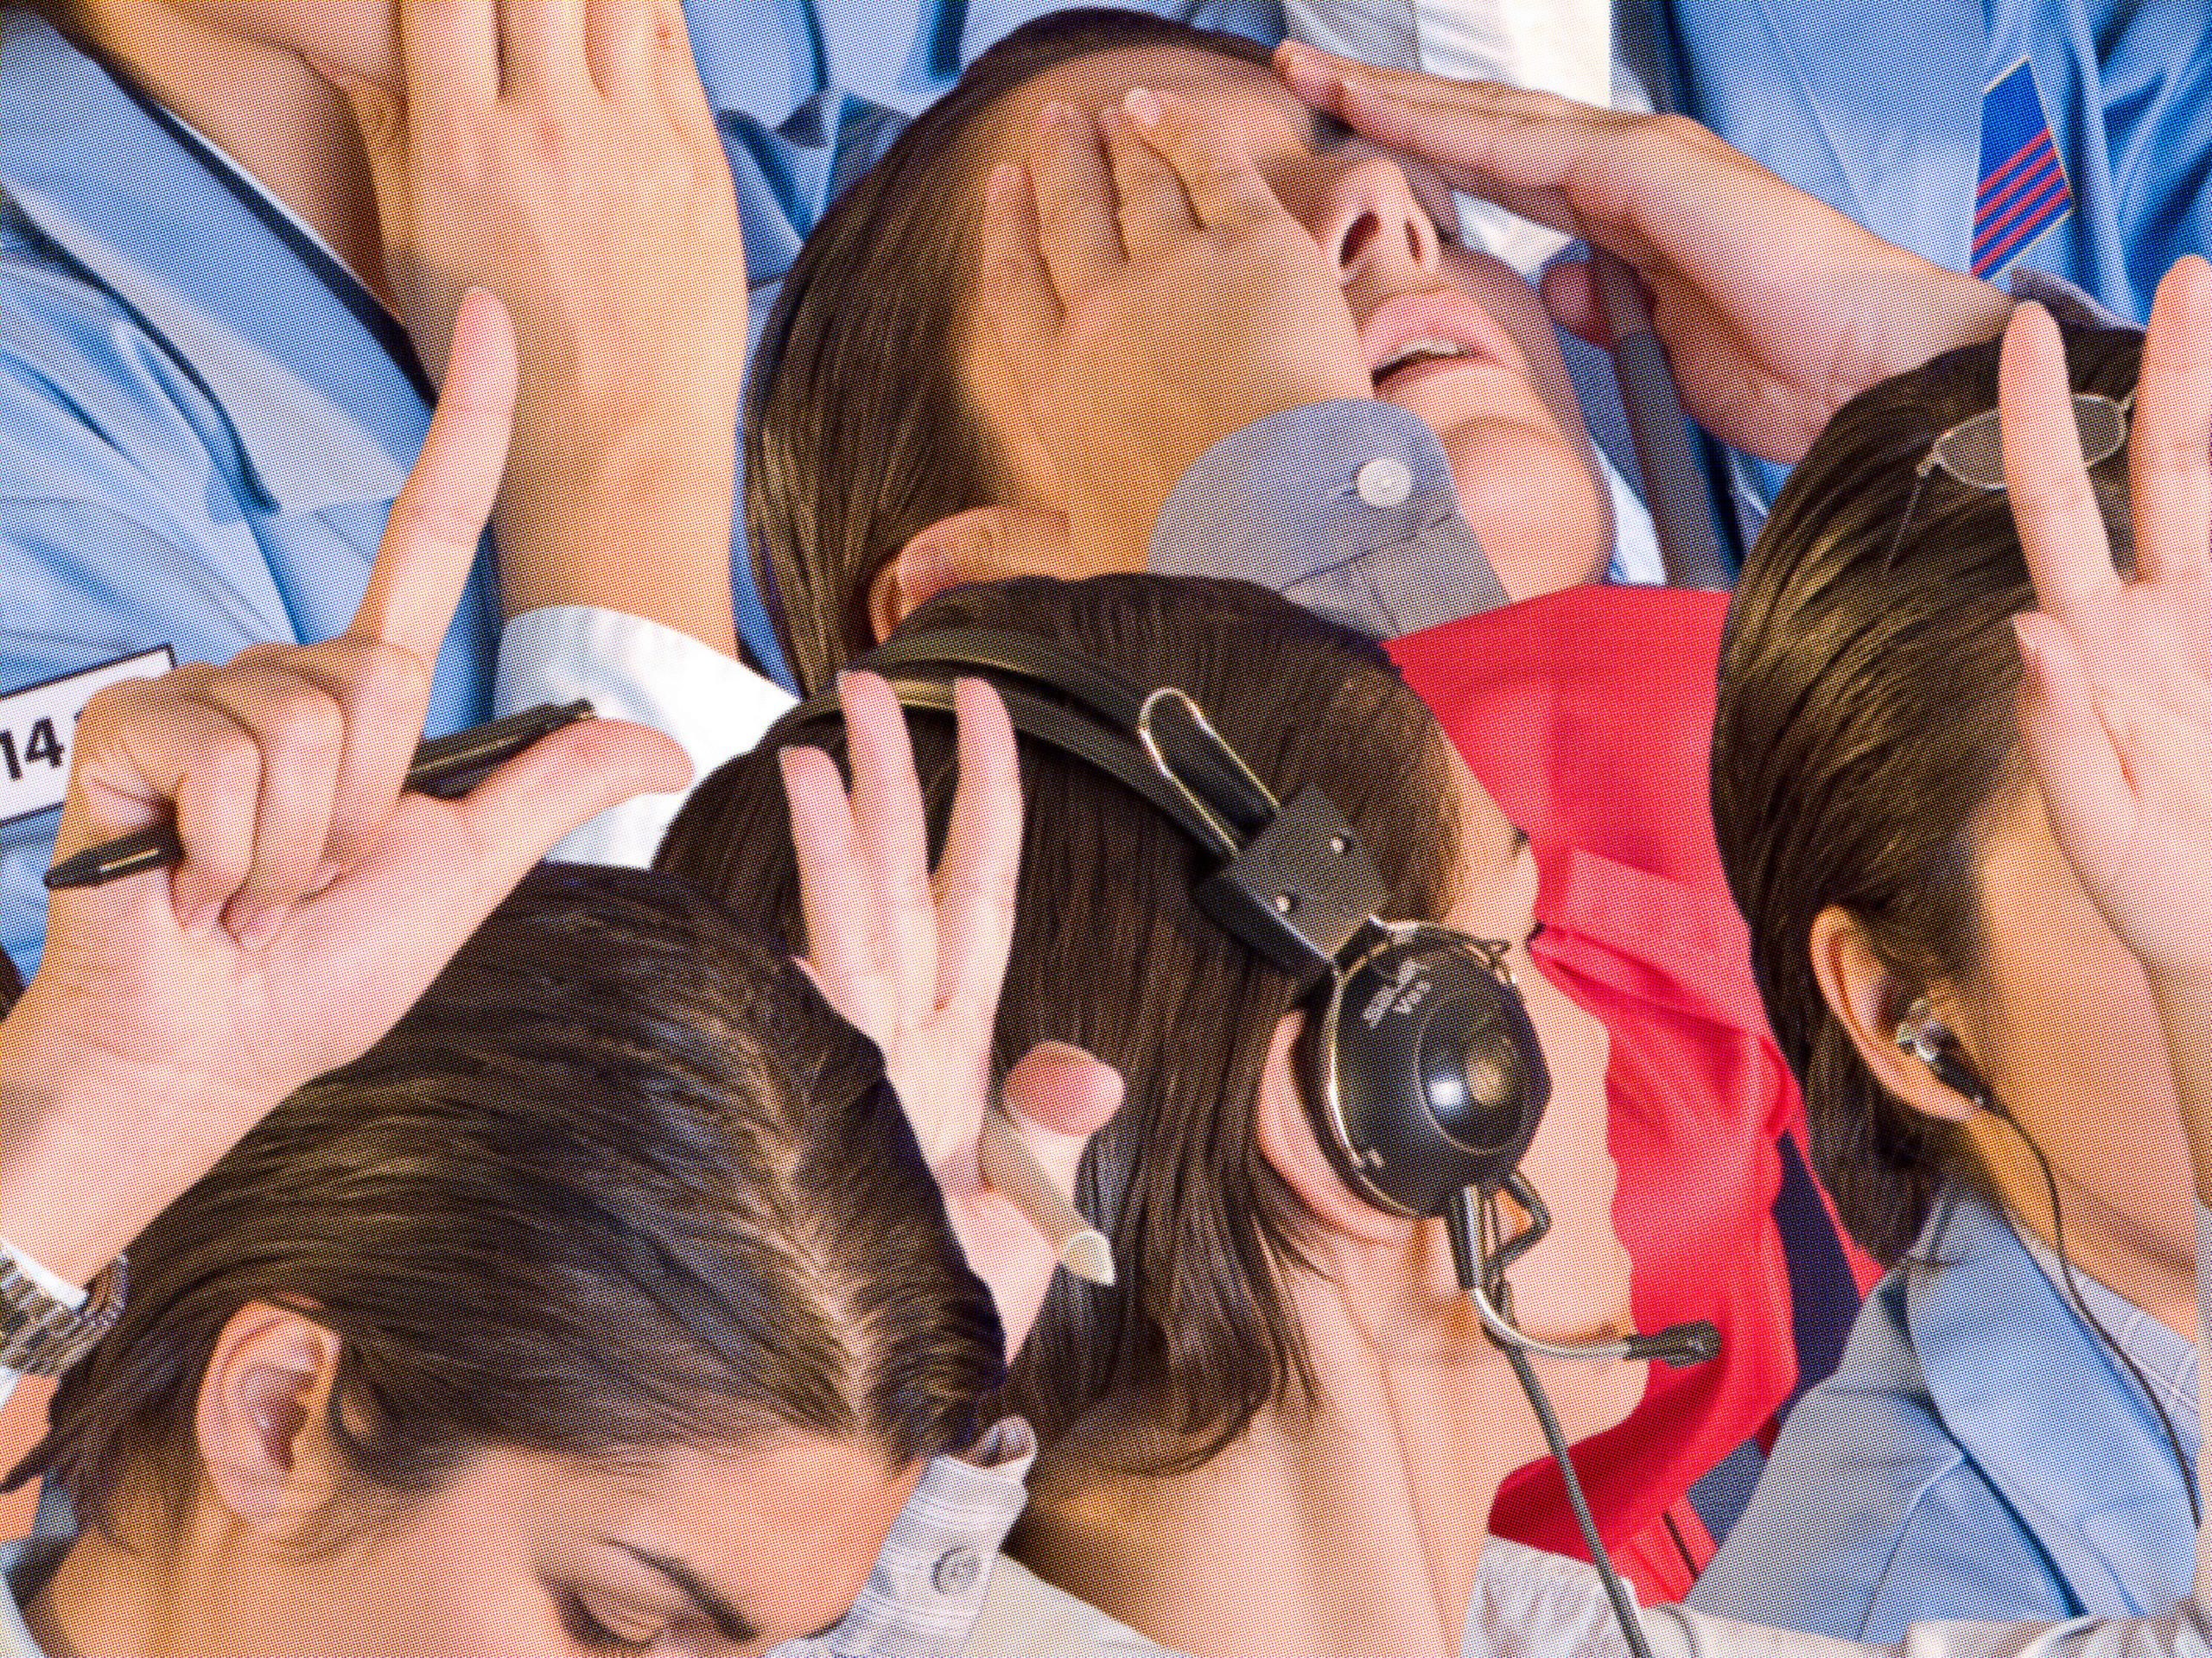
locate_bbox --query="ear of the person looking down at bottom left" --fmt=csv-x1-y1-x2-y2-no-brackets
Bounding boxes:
194,1302,343,1536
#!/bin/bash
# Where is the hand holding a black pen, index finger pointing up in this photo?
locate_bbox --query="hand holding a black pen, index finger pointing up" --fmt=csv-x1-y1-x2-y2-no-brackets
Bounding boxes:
0,294,686,1275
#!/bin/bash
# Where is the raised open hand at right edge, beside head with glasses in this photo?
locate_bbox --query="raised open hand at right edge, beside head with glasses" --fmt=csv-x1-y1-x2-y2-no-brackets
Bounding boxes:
1999,257,2212,988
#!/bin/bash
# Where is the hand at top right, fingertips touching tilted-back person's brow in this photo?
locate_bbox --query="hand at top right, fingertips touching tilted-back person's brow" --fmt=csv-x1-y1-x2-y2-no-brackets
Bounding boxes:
1276,44,2011,462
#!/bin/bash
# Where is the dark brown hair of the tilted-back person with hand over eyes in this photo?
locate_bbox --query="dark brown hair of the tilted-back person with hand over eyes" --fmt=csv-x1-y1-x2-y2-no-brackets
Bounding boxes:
746,9,1269,694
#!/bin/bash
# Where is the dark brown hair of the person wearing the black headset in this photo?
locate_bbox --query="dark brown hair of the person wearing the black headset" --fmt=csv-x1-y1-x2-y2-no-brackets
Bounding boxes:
659,575,1460,1471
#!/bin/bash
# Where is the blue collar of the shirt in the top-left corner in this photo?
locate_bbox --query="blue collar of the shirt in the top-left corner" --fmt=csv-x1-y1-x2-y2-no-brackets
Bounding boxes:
0,9,429,513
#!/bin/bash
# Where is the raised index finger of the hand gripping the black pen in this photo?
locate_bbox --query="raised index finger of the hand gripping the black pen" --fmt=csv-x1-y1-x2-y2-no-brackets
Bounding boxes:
347,288,515,668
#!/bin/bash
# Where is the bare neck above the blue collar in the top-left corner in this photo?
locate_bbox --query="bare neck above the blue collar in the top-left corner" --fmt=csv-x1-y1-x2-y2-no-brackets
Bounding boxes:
63,0,390,303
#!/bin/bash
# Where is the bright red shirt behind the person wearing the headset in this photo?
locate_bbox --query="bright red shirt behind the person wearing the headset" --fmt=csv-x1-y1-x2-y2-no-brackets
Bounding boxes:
1389,588,1872,1600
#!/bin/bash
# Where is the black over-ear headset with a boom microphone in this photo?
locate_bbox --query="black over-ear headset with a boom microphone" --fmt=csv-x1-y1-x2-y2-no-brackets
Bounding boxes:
791,628,1719,1364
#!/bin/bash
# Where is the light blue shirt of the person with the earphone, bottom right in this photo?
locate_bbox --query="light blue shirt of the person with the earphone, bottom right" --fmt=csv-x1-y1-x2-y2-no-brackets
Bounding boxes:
1690,1196,2199,1642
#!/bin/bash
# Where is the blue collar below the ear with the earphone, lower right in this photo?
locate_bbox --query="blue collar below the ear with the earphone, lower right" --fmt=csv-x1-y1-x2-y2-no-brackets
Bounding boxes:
1903,1194,2195,1611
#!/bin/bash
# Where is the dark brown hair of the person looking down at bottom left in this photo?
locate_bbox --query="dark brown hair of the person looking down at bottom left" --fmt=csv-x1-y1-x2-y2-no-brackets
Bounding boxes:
16,869,1004,1530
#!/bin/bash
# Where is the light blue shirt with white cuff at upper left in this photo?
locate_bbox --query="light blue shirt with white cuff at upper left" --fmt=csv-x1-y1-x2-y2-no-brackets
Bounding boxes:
0,9,814,973
